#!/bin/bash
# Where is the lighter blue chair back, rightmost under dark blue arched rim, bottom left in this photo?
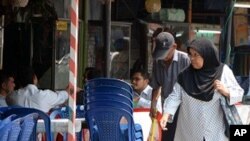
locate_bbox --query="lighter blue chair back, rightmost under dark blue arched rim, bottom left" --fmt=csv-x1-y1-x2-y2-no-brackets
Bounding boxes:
18,113,39,141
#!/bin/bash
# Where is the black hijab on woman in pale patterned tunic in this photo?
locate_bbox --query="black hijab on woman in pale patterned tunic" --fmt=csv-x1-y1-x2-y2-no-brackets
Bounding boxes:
178,38,223,101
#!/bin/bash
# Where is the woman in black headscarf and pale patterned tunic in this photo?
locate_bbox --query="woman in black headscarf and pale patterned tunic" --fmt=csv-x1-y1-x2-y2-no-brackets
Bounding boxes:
160,38,244,141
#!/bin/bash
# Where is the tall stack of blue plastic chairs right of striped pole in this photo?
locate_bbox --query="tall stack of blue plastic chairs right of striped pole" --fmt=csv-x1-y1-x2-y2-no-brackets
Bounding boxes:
85,78,143,141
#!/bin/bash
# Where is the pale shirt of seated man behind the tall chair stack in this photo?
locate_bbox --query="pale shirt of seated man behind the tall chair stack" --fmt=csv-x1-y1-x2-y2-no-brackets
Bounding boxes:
134,85,162,113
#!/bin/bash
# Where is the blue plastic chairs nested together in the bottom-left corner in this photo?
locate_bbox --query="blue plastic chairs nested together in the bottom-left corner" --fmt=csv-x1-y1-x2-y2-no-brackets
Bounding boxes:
0,107,51,141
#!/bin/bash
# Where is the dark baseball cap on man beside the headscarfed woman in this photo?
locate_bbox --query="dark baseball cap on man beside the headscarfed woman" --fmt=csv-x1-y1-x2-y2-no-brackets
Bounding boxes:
152,32,175,60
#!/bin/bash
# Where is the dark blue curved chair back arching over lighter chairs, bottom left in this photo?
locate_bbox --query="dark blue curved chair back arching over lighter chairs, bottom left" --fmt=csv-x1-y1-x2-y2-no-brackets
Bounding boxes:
0,106,52,141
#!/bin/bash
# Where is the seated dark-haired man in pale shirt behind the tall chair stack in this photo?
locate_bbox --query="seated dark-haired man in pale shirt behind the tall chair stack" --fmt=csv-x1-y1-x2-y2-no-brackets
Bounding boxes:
131,69,162,113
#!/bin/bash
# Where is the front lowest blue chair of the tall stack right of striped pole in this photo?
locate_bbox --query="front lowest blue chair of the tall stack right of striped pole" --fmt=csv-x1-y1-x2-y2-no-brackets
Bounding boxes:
86,106,135,141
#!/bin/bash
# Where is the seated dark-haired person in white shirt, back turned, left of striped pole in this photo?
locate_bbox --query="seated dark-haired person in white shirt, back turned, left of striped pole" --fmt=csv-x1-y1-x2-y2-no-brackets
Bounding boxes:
6,67,80,113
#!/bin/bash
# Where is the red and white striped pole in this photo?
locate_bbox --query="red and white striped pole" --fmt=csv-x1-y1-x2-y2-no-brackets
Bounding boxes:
68,0,79,141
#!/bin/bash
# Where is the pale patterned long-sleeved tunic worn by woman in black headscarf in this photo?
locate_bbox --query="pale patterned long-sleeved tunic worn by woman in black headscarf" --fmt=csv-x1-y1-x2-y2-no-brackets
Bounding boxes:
164,65,244,141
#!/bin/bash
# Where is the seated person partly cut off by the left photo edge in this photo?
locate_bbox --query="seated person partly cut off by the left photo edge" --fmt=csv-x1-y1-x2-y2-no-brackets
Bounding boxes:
0,70,16,107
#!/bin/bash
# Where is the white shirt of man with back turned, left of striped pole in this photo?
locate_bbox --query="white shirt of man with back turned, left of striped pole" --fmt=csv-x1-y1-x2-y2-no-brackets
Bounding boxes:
8,84,69,113
